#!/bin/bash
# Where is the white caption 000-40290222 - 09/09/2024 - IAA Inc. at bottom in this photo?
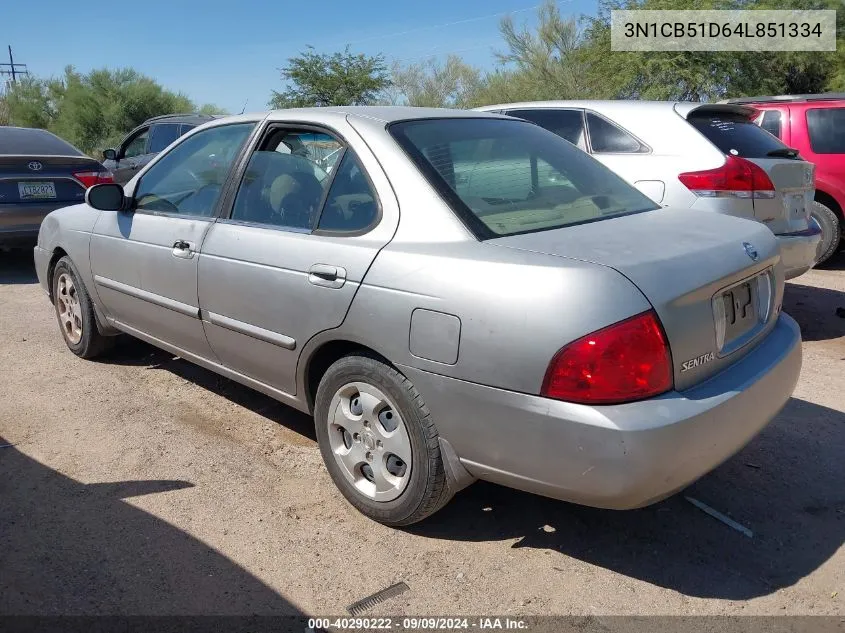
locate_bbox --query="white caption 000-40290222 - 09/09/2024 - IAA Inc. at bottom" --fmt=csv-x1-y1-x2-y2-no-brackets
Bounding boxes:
306,617,529,631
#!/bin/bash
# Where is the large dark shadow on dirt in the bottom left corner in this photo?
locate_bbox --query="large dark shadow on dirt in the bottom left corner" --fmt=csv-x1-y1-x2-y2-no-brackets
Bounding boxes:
0,438,302,612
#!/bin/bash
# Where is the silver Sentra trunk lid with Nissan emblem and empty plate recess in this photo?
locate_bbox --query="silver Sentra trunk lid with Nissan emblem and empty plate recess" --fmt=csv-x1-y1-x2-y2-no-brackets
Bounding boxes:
487,208,783,390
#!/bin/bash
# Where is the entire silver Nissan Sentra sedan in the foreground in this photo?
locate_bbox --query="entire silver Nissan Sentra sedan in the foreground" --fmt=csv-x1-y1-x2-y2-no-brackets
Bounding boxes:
35,107,801,525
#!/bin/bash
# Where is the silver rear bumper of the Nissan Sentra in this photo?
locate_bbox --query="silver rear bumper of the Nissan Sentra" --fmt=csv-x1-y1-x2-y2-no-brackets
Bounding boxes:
401,315,801,509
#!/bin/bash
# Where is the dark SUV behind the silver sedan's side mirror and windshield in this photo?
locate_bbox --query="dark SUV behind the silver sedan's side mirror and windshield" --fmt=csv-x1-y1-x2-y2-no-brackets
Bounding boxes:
103,114,215,185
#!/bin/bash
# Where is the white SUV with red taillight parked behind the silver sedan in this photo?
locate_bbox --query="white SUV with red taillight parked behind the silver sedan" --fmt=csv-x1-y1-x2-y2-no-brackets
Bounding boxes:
479,100,821,279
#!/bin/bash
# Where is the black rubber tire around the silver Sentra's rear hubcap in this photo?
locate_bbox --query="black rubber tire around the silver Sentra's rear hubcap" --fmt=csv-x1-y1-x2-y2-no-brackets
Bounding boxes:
314,354,451,527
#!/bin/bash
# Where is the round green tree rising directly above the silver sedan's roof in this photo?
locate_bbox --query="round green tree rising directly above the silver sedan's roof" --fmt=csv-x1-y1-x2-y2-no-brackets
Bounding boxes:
269,46,390,108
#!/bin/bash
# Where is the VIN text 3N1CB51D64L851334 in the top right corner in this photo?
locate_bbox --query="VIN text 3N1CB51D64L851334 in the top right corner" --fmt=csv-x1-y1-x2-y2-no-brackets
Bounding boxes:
623,22,822,38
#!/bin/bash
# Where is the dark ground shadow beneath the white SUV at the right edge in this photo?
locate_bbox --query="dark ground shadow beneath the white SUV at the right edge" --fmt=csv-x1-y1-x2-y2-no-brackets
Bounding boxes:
783,278,845,341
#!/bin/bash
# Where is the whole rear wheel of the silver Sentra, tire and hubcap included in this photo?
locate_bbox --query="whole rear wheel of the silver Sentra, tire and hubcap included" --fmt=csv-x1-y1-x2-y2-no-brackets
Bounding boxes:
314,355,449,526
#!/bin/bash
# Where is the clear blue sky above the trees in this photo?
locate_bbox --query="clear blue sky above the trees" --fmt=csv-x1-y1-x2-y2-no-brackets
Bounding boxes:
8,0,597,112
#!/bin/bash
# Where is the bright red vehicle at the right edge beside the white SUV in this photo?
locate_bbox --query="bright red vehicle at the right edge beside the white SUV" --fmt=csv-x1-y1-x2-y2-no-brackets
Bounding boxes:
729,93,845,263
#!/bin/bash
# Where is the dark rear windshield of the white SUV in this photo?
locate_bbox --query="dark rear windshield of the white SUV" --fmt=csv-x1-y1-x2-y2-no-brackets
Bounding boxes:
687,112,788,158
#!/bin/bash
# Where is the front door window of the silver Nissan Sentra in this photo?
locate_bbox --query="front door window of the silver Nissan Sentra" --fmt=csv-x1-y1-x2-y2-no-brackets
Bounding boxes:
135,123,255,217
